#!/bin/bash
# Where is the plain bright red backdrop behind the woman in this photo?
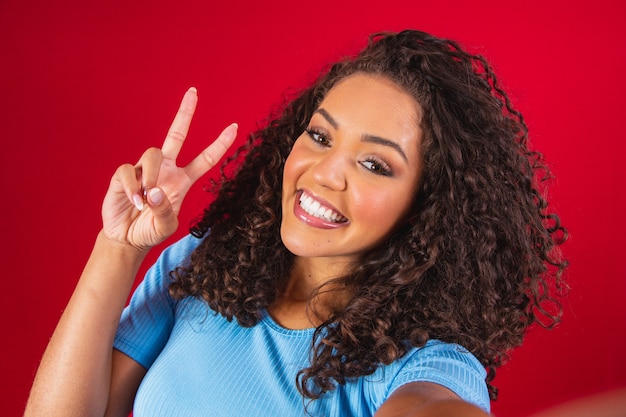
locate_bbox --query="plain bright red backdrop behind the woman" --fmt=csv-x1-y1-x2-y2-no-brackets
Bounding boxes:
0,0,626,417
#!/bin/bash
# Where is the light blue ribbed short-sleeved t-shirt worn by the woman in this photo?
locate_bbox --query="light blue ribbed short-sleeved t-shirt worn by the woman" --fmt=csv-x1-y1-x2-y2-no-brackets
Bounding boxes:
114,236,490,417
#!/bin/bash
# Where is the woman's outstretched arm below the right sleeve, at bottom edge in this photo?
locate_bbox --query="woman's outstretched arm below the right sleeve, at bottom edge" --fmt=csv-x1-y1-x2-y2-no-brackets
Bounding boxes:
375,382,489,417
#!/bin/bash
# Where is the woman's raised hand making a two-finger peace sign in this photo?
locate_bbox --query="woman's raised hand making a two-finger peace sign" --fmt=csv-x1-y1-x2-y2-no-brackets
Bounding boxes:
102,88,237,250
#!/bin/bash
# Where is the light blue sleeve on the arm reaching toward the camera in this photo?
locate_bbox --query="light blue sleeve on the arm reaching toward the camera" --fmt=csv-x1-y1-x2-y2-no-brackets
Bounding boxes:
378,340,490,412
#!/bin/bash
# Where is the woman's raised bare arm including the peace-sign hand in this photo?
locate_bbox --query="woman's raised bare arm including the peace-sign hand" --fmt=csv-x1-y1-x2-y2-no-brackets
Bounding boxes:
25,89,237,417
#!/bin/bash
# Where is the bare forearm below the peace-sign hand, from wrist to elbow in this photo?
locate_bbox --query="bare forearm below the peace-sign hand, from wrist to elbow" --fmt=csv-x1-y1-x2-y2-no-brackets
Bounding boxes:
25,233,145,416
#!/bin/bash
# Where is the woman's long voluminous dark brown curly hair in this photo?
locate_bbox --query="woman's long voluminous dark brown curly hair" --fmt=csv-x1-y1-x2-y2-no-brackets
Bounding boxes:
170,30,567,399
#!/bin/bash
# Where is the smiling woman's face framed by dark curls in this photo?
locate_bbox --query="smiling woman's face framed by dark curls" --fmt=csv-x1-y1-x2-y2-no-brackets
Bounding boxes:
281,73,422,261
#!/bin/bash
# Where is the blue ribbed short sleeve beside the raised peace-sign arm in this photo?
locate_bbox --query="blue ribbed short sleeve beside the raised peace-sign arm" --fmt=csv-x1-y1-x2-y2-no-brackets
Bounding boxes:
113,235,201,369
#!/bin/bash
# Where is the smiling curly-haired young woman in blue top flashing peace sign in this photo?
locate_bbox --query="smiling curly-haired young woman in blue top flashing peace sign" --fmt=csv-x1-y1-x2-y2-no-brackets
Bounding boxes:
26,31,566,417
